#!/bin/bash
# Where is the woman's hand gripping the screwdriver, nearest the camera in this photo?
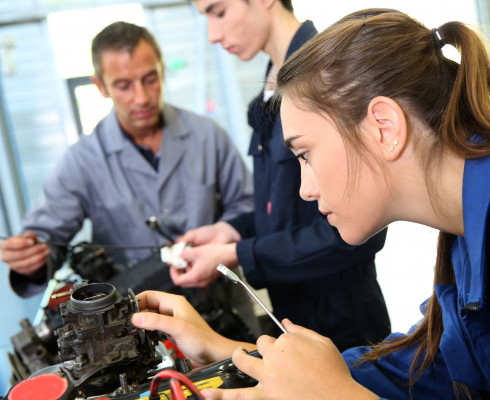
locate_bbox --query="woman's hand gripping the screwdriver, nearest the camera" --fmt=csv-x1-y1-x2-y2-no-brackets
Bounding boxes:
203,320,379,400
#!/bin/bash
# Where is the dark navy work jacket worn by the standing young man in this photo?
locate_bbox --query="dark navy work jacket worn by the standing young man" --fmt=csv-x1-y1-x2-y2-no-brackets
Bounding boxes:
229,21,389,345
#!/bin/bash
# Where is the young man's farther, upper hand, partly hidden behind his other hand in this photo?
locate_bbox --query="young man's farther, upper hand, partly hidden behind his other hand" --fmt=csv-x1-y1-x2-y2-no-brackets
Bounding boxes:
177,222,242,246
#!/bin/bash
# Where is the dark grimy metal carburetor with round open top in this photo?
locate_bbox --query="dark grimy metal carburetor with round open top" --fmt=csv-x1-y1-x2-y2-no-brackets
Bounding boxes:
55,283,162,395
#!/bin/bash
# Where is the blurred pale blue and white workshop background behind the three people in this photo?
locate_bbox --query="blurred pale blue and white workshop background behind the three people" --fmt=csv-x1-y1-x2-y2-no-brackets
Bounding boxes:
0,0,490,396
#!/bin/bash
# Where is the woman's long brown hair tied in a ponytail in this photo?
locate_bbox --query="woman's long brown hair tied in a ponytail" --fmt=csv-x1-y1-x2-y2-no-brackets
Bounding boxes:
277,10,490,395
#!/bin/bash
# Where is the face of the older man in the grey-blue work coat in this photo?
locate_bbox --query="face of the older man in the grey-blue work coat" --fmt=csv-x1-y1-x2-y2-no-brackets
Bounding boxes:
93,40,163,136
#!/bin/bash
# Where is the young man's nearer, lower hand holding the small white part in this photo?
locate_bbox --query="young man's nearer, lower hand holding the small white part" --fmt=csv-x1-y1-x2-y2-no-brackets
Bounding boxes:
170,243,238,288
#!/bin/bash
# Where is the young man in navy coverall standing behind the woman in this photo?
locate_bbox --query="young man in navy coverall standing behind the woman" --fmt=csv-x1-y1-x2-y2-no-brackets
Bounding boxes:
171,0,390,350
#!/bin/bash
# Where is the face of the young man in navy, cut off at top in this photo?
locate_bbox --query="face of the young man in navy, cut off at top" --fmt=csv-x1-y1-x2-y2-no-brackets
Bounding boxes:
194,0,271,61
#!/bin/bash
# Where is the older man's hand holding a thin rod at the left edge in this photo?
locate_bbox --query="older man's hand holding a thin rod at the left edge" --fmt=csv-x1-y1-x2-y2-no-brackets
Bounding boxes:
0,232,49,277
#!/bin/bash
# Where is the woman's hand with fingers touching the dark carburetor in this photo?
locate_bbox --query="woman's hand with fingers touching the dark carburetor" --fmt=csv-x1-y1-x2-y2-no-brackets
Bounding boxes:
131,291,255,366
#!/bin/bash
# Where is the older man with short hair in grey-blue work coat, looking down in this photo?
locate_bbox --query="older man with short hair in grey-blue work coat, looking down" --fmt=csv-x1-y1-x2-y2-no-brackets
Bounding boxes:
0,22,254,334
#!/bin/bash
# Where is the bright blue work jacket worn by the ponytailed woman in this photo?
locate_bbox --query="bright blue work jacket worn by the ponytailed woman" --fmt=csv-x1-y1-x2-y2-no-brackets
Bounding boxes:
343,152,490,400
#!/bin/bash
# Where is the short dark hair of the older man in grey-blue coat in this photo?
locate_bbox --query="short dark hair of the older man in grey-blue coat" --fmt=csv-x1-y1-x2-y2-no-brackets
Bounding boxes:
92,21,162,80
